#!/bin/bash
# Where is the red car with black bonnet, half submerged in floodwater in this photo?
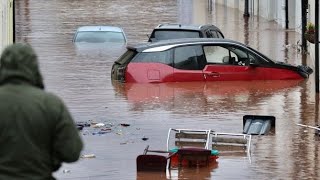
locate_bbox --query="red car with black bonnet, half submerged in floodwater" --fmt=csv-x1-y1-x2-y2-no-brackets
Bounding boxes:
111,38,313,83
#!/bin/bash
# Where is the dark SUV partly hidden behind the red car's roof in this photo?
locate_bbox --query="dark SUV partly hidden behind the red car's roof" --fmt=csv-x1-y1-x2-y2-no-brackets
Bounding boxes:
148,24,224,42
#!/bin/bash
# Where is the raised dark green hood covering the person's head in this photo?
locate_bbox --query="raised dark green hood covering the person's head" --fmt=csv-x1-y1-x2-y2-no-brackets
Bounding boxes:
0,43,44,89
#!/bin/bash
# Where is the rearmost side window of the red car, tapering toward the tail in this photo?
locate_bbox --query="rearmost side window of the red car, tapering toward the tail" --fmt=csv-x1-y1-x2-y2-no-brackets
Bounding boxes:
132,50,172,65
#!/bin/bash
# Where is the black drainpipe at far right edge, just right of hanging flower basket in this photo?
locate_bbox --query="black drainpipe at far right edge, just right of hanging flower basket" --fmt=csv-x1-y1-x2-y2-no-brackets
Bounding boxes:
314,0,319,93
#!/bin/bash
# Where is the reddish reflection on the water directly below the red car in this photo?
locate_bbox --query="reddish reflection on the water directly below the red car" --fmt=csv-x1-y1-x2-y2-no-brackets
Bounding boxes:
113,80,301,114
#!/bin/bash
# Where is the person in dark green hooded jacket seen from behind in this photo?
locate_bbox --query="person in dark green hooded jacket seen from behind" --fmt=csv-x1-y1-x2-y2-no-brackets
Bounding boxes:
0,43,83,180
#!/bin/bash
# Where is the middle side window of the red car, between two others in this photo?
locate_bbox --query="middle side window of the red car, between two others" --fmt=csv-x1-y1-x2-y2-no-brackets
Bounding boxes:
174,46,203,70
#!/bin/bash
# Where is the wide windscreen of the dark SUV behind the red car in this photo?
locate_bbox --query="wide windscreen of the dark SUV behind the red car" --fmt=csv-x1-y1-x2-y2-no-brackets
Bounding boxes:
151,30,200,40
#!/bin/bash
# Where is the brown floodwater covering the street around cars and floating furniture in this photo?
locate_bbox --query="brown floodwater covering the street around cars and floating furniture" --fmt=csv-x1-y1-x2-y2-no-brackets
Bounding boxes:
15,0,320,180
